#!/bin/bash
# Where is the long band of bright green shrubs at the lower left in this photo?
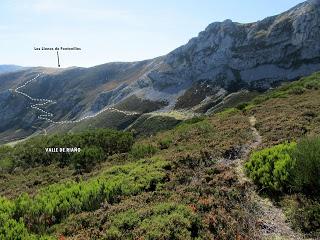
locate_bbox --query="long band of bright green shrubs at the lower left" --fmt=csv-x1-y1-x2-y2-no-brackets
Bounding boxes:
0,159,167,236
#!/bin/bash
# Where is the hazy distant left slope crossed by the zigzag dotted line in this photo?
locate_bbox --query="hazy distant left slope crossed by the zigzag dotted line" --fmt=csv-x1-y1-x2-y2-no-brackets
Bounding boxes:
0,61,165,140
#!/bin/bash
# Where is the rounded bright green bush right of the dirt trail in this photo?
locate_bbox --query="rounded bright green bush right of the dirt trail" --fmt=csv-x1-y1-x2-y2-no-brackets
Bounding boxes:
245,137,320,195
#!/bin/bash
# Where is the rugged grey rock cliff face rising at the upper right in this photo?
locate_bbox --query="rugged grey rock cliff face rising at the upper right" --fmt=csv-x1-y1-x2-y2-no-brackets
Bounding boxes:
142,0,320,95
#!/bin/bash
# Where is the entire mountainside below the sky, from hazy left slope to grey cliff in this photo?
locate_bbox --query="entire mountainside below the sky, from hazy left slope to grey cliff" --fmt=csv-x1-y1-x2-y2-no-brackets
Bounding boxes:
0,0,320,142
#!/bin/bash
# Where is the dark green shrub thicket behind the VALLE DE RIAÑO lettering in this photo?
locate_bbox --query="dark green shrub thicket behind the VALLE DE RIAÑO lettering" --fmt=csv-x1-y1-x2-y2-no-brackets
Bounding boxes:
8,129,133,170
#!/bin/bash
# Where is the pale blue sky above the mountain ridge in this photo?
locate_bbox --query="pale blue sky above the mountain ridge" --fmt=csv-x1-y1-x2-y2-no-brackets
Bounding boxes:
0,0,302,67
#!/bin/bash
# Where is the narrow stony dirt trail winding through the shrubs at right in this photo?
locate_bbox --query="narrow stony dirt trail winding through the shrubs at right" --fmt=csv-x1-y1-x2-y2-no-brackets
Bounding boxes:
236,116,304,240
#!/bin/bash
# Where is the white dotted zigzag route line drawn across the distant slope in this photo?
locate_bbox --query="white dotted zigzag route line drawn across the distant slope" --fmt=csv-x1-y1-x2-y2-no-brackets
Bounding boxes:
9,73,141,124
